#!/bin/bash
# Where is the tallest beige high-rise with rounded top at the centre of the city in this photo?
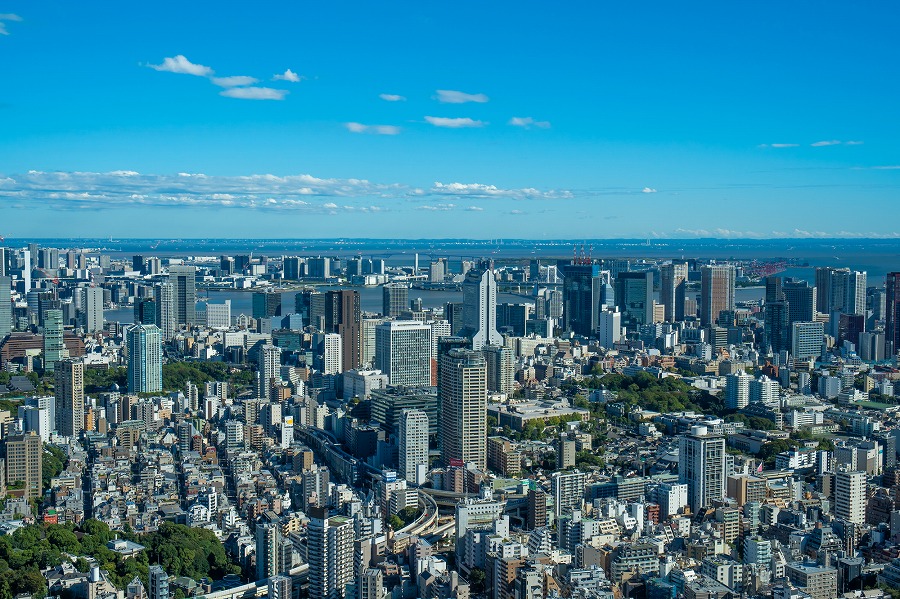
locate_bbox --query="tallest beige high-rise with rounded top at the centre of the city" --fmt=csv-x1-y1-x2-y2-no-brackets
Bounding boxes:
438,349,487,470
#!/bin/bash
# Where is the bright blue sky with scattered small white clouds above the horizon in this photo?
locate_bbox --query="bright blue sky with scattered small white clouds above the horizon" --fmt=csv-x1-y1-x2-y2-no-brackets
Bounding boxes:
0,1,900,238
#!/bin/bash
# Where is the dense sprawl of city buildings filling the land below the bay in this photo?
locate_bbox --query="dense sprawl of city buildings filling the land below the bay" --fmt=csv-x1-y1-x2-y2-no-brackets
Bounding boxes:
0,245,900,599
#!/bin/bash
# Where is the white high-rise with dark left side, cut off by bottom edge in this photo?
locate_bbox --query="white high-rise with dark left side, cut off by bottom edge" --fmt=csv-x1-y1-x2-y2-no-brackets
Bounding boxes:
307,507,354,599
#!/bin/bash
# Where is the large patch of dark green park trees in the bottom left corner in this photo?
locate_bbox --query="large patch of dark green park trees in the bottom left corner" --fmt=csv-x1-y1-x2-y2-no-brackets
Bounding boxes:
0,520,240,599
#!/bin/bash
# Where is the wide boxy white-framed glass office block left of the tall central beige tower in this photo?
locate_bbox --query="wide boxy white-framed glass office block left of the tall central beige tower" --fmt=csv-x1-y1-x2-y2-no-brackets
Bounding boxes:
375,320,432,387
